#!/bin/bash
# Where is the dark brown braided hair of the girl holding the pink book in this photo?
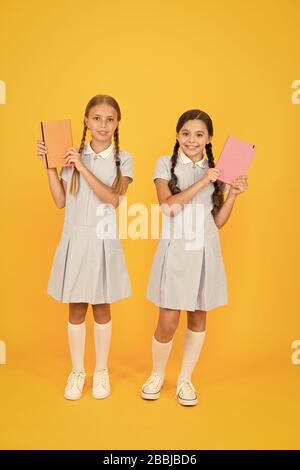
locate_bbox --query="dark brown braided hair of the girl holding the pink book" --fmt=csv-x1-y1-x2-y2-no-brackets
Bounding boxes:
168,109,224,215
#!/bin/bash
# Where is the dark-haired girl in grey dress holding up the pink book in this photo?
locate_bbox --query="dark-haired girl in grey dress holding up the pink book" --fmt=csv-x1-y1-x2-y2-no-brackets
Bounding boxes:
141,109,247,405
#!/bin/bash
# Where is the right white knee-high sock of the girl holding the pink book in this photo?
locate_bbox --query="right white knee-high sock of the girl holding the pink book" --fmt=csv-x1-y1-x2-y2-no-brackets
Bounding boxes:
178,328,206,380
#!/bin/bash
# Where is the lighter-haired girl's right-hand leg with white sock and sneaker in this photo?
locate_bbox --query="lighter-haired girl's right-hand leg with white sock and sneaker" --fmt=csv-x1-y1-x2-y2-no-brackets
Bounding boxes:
92,304,112,399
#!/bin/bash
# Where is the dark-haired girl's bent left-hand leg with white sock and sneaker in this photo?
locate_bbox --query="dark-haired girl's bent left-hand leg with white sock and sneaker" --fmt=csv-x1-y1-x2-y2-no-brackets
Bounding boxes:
141,308,180,400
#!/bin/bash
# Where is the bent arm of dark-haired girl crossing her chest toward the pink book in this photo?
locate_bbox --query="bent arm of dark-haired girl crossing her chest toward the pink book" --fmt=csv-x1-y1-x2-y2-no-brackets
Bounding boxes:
155,168,220,217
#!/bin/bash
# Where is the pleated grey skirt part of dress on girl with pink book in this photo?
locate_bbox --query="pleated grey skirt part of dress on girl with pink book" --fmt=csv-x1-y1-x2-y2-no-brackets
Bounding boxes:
147,236,228,311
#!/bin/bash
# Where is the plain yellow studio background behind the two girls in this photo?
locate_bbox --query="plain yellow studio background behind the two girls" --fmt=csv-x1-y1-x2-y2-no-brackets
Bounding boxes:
0,0,300,449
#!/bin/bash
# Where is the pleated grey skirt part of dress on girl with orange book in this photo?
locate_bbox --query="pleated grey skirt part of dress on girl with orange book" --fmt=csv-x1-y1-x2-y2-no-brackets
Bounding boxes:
47,224,131,304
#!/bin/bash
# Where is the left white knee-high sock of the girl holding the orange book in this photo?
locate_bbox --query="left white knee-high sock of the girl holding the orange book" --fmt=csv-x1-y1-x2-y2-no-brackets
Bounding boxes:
68,321,86,372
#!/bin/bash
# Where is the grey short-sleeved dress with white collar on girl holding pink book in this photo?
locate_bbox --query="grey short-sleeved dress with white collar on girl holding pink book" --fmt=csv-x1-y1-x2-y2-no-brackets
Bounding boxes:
147,150,228,311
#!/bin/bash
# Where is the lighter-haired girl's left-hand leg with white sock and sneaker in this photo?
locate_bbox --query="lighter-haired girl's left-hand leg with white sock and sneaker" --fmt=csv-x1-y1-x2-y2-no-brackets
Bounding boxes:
65,302,88,400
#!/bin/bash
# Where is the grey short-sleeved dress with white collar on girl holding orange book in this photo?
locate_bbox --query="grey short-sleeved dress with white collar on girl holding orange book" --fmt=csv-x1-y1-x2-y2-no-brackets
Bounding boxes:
47,143,133,304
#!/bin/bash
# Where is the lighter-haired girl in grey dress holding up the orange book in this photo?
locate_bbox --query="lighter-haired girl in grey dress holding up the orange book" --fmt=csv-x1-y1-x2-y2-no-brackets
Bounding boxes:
38,95,133,400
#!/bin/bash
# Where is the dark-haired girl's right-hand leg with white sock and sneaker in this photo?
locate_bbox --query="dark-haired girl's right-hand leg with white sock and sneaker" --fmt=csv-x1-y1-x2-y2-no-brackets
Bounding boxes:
177,310,206,405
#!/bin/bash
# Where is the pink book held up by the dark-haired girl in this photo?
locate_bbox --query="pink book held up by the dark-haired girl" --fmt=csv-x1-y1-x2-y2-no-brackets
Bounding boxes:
215,135,256,184
